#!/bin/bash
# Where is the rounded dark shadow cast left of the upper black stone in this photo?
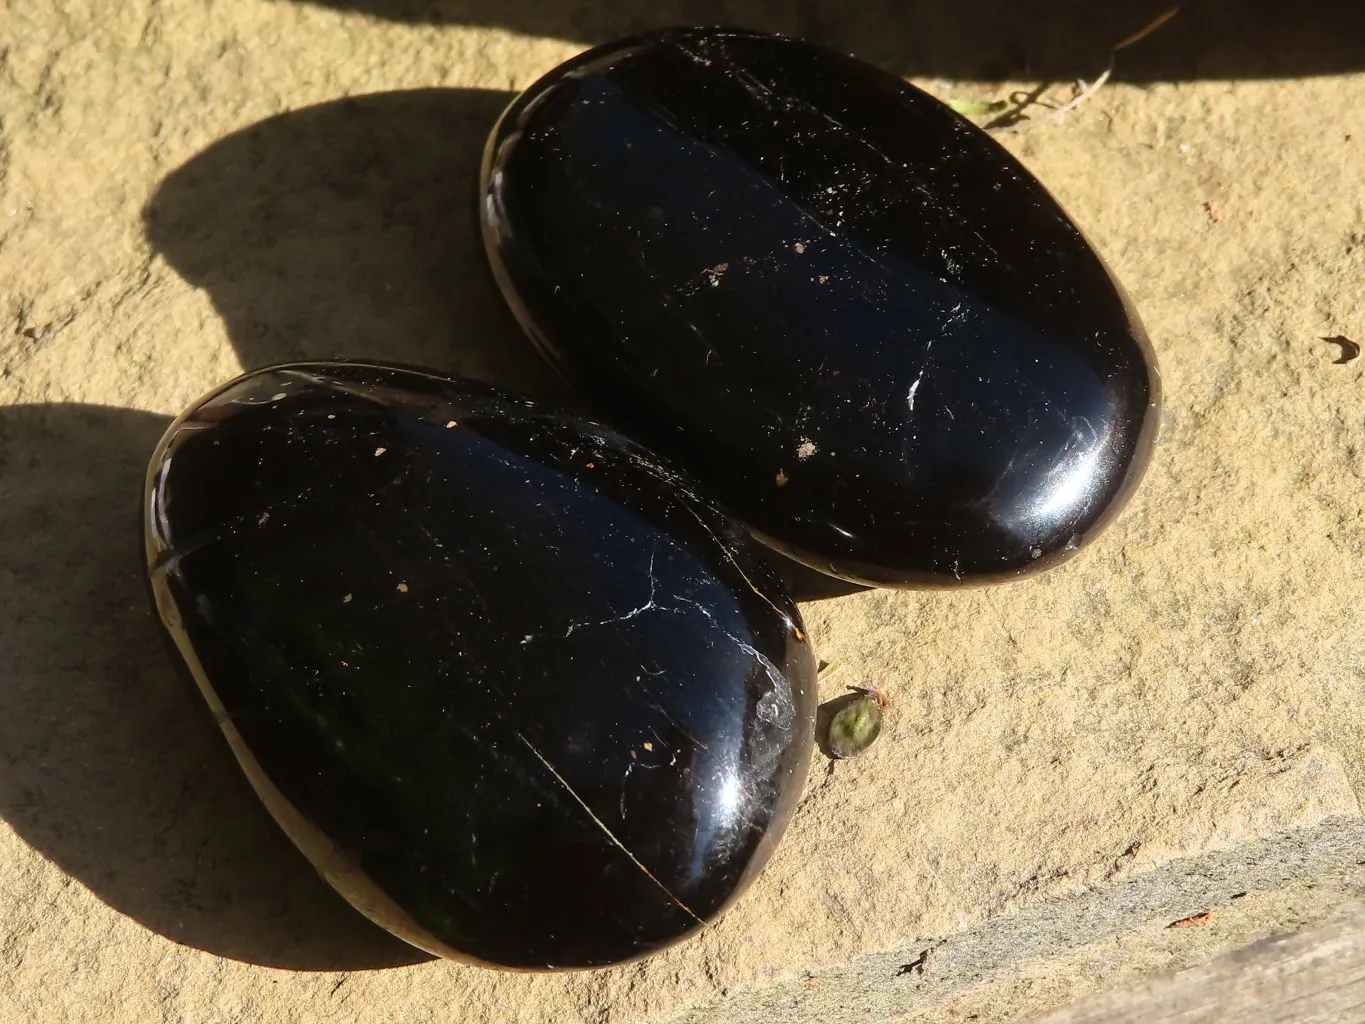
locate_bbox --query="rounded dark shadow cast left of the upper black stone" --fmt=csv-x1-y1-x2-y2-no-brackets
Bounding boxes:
145,89,572,403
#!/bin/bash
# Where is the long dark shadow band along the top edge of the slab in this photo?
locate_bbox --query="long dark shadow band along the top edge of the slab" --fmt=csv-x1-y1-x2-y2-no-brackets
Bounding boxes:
276,0,1365,82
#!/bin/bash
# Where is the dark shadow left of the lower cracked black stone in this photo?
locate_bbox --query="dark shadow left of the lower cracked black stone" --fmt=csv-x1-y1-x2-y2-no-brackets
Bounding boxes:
0,406,429,971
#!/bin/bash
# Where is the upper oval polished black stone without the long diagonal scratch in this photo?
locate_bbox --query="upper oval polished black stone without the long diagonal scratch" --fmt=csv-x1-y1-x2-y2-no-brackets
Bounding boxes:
482,29,1159,586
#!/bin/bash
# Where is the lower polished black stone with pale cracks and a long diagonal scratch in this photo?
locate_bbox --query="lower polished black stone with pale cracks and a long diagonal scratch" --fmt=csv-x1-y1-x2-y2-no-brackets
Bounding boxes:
145,363,815,968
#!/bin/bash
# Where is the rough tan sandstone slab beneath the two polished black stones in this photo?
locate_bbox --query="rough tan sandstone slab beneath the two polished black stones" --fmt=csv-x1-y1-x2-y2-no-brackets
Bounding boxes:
0,0,1365,1024
